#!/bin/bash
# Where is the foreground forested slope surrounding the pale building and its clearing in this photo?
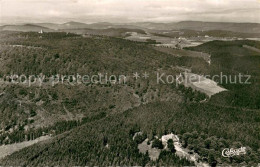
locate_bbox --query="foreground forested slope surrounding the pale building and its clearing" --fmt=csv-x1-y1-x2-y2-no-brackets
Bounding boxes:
1,102,259,166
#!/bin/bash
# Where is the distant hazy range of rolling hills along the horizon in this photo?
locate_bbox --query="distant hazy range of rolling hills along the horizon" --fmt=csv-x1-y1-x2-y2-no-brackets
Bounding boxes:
0,21,260,37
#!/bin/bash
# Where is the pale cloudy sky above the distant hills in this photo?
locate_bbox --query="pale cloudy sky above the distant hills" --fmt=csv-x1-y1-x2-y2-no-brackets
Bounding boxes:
0,0,260,23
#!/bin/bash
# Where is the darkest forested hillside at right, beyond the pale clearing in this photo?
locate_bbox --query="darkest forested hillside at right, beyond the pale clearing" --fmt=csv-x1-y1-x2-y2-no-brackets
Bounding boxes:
188,40,260,109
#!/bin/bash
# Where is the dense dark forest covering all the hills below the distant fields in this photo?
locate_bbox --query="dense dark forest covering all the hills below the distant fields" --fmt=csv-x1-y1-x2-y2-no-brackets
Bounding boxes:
0,32,260,166
